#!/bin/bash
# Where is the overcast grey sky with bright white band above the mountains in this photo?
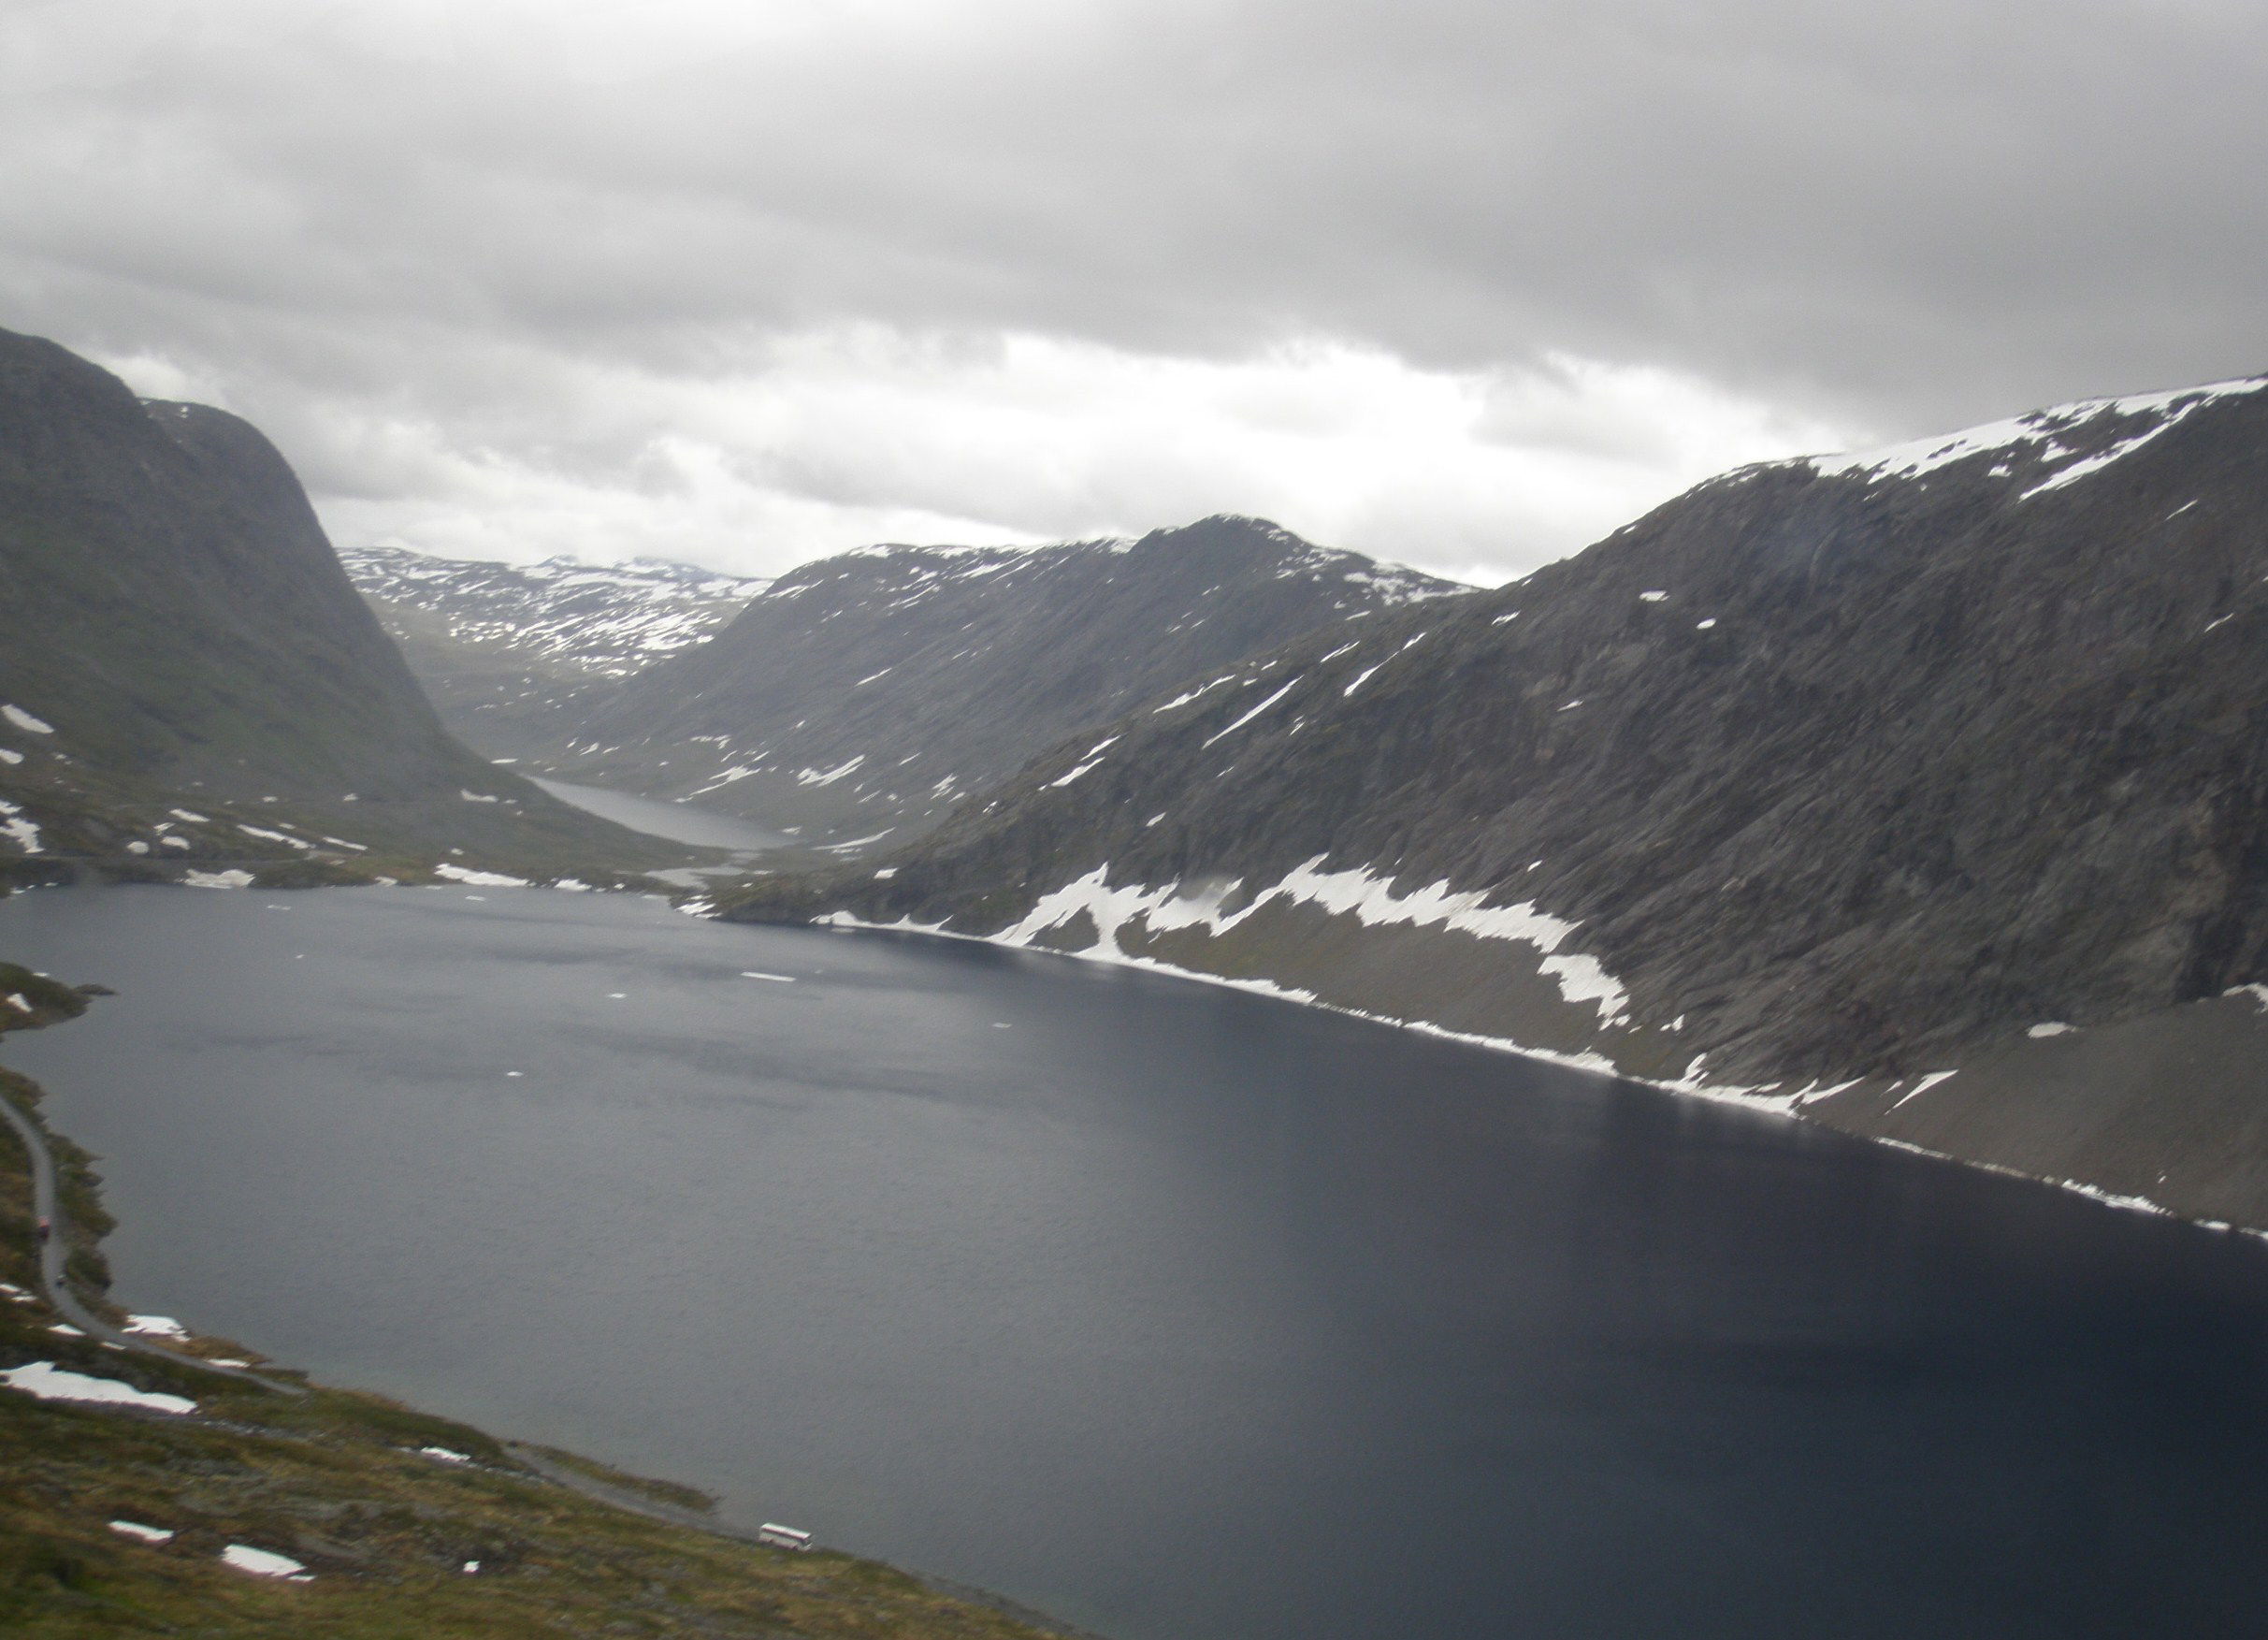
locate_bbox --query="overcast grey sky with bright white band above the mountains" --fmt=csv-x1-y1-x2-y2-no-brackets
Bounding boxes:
0,0,2268,581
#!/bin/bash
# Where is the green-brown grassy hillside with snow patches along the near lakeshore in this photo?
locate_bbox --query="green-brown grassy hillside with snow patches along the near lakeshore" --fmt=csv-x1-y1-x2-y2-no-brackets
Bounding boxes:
0,993,1070,1640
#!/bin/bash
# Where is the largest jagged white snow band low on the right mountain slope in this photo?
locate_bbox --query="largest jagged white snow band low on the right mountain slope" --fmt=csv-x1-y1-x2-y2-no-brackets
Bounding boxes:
996,855,1631,1025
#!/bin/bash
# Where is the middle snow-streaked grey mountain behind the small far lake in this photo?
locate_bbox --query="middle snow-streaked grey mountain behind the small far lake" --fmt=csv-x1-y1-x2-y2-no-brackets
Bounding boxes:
533,517,1466,849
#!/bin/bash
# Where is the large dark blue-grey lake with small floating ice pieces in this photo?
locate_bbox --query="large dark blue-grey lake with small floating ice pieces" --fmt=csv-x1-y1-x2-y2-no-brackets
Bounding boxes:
0,889,2268,1640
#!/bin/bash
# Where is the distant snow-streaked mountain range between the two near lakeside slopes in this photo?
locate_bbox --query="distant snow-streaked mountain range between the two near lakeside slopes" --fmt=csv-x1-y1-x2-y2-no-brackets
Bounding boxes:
347,517,1467,849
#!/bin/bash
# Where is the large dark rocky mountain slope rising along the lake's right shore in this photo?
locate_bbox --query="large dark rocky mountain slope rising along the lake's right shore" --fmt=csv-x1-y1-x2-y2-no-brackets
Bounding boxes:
724,379,2268,1225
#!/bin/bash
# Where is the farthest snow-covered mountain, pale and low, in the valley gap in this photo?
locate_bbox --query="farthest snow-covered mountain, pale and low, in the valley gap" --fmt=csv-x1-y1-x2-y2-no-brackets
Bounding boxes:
338,546,769,755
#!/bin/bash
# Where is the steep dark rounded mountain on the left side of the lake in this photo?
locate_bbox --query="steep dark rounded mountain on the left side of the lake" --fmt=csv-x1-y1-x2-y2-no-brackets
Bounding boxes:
0,331,683,876
